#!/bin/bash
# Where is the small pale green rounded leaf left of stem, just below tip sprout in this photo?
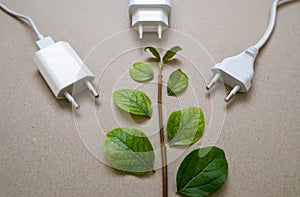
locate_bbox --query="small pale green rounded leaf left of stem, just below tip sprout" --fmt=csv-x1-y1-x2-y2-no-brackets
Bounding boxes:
129,62,154,82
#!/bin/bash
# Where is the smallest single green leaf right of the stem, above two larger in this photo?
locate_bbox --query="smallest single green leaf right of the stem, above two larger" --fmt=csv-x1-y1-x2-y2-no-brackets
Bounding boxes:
167,69,189,96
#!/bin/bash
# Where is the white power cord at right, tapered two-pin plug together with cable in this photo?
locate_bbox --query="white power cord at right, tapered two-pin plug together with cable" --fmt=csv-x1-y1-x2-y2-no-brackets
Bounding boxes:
206,0,296,102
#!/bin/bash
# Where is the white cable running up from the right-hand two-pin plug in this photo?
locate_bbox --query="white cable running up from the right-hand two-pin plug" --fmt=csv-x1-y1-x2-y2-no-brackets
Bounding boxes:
254,0,298,50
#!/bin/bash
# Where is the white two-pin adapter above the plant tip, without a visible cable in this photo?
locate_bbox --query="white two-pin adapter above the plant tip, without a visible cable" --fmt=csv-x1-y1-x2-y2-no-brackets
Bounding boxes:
129,0,171,39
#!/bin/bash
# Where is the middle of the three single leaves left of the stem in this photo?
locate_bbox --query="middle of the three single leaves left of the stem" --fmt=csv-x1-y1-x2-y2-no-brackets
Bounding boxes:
113,89,152,118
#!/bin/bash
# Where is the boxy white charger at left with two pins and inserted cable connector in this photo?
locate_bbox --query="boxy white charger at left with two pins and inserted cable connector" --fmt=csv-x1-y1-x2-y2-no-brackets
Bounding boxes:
33,37,99,109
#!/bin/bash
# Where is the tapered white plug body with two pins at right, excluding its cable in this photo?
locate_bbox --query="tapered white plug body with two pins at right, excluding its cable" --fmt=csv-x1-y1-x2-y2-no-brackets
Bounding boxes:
206,47,258,102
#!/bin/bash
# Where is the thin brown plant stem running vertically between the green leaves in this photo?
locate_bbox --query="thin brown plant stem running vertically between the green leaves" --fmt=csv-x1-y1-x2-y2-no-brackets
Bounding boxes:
157,62,168,197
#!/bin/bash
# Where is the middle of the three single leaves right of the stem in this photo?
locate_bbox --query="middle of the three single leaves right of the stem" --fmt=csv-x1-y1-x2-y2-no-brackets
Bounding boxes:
167,107,205,146
